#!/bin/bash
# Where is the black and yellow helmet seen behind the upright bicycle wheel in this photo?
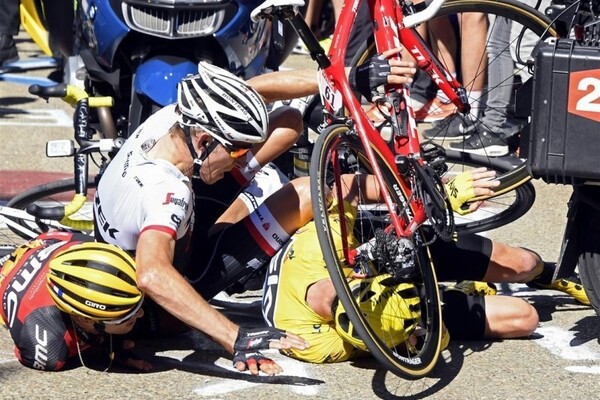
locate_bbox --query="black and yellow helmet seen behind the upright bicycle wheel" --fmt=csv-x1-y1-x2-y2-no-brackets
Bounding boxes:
334,274,421,350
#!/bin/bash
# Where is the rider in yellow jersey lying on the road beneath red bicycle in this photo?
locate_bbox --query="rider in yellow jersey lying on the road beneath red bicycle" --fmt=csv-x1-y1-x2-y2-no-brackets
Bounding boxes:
262,170,581,363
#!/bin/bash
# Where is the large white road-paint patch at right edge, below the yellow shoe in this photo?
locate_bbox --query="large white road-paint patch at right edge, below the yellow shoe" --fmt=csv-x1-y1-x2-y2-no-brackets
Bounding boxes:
533,326,600,361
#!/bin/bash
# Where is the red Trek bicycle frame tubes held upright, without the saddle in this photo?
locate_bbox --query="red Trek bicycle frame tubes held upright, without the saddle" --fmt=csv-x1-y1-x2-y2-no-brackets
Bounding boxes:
321,0,469,247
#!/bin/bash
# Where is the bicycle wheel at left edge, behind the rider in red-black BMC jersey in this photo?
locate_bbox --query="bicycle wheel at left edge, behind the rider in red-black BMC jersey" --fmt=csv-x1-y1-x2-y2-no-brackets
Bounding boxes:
6,178,96,239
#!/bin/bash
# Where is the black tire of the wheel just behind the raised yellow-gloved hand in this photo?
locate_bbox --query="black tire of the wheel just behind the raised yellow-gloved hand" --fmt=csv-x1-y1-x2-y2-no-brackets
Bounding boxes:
446,150,535,233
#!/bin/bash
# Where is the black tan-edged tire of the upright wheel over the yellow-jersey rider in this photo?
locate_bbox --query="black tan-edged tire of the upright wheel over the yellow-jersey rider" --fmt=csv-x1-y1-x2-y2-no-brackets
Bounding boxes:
310,125,442,379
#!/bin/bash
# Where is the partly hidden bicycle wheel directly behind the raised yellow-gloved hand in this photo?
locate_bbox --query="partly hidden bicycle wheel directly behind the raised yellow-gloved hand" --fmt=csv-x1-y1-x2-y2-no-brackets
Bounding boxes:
444,150,535,233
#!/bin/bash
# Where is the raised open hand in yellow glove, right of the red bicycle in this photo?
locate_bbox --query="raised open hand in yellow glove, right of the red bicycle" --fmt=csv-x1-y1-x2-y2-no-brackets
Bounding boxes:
446,167,500,215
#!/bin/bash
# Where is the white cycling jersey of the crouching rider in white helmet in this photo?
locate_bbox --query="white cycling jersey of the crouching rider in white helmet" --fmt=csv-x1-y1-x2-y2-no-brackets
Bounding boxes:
94,104,193,251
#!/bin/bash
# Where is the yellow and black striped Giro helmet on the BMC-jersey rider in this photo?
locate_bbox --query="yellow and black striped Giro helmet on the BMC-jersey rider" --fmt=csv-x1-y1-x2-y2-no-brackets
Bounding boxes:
47,242,143,323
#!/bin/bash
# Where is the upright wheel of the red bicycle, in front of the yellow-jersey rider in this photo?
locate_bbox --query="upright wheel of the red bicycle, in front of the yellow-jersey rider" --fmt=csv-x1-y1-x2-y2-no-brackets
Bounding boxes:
310,125,442,379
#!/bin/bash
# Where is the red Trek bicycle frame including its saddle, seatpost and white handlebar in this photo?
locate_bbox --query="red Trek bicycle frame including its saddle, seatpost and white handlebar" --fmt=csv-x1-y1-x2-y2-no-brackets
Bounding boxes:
252,0,470,260
